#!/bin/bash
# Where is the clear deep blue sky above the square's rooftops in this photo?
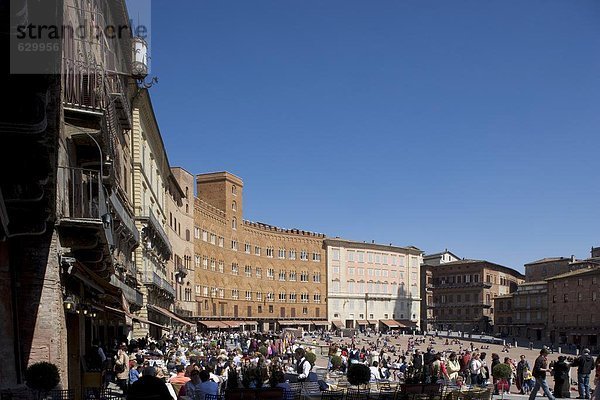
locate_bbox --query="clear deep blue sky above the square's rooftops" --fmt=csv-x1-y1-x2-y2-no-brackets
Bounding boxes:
144,0,600,270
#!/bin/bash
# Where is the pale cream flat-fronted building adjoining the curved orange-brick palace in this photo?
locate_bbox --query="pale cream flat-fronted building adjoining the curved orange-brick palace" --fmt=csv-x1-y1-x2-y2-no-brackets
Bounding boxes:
325,238,422,330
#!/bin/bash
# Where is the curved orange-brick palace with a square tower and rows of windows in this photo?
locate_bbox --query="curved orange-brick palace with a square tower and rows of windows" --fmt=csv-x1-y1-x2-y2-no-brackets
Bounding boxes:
194,172,327,330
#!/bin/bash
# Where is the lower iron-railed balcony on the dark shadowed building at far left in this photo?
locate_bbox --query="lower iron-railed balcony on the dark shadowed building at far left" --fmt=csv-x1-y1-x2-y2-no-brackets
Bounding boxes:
57,167,114,278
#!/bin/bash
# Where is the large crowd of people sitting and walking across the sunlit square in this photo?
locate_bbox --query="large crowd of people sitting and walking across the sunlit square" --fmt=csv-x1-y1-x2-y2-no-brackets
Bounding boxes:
92,331,600,400
